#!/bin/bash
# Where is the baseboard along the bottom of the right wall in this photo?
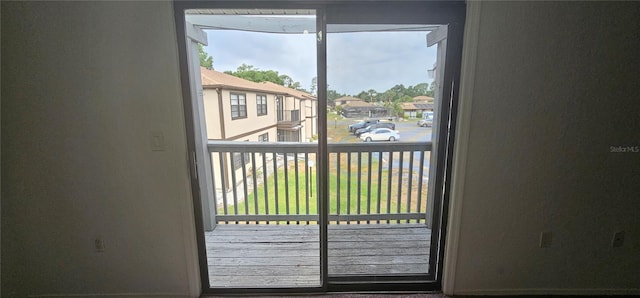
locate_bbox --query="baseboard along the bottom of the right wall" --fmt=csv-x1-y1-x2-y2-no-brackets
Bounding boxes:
454,288,640,296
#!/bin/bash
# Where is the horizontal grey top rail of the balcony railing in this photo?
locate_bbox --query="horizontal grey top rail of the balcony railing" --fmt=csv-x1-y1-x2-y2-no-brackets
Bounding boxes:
207,140,433,153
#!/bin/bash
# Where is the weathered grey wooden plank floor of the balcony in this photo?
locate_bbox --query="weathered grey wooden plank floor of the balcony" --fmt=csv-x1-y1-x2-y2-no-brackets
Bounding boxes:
205,224,431,288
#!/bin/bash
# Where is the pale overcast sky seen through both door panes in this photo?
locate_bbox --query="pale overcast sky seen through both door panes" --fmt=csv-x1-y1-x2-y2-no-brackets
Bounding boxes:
204,31,436,95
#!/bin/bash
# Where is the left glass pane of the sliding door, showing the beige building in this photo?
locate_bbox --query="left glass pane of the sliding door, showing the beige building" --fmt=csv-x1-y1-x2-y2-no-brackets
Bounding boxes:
185,8,320,288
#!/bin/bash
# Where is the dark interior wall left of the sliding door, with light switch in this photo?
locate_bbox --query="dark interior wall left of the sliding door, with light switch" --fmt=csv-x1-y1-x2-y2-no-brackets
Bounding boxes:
2,1,199,297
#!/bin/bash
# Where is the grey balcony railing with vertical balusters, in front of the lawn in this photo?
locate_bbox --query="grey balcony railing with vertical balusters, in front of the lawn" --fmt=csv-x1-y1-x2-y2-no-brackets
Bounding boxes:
208,141,432,224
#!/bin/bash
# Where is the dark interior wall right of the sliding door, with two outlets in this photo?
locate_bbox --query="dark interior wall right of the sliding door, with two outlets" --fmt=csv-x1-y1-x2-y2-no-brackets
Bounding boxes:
447,1,640,294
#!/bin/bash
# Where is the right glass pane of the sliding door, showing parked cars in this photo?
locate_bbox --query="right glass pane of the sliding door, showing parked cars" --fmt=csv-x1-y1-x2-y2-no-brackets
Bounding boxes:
327,22,440,281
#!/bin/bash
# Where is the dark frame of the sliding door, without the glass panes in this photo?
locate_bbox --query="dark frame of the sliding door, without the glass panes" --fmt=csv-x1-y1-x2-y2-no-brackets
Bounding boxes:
173,0,466,294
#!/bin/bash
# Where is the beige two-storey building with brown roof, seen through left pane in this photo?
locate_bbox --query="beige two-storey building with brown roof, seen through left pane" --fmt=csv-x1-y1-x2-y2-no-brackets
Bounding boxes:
200,67,318,142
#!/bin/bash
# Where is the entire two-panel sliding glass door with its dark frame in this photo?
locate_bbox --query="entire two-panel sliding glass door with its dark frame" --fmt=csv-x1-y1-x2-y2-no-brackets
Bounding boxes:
175,1,464,293
